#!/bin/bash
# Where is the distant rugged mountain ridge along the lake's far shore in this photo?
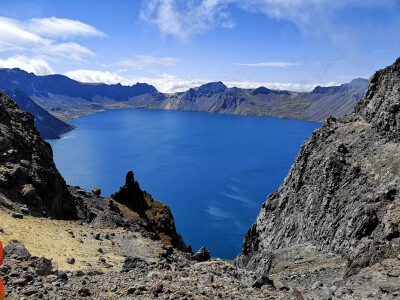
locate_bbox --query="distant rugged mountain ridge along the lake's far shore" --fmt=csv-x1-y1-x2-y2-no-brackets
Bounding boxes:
0,69,368,122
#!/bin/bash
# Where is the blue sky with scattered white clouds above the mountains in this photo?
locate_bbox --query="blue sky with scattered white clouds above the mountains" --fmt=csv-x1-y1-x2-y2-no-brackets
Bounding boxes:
0,0,400,92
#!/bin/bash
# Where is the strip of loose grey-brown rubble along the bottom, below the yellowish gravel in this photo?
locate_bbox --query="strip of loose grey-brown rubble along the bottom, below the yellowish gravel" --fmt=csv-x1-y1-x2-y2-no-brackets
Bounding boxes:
0,243,295,300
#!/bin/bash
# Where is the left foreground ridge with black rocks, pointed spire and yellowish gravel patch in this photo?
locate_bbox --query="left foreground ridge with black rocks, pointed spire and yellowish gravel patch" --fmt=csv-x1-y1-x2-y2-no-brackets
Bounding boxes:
0,94,294,300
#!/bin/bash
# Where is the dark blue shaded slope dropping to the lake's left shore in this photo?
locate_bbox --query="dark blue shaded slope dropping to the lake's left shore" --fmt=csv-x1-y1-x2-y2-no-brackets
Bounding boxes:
2,90,75,139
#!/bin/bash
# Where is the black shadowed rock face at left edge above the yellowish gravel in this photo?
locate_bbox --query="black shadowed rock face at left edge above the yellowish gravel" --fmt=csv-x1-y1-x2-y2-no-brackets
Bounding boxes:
0,93,77,219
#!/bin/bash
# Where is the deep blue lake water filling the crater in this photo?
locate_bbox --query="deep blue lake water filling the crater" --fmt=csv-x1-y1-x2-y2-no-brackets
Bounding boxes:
49,109,320,259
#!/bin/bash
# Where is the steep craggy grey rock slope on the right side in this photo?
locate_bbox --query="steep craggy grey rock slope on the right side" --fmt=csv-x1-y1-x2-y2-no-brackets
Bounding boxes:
236,59,400,299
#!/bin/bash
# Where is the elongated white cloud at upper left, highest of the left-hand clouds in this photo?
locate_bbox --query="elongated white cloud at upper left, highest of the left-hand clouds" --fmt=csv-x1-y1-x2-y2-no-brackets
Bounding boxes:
25,17,105,39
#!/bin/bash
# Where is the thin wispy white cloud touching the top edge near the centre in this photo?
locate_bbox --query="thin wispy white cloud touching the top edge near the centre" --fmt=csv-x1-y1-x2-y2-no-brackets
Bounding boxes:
140,0,234,41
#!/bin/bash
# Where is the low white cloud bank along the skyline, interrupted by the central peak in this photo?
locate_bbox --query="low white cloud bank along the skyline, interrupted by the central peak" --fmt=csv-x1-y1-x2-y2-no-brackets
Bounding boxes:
64,70,335,93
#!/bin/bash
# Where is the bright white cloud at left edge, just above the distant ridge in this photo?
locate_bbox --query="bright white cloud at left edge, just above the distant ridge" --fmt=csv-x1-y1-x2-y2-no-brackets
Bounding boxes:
0,55,54,75
